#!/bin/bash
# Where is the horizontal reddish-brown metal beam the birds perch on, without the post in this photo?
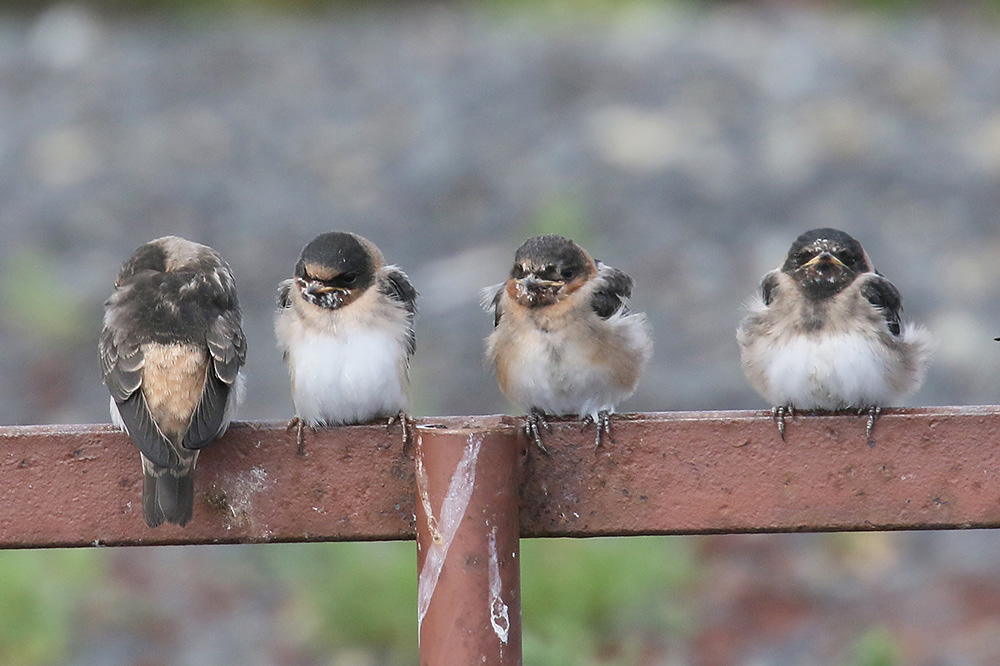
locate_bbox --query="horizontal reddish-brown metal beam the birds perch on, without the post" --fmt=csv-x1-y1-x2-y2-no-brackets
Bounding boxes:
0,406,1000,548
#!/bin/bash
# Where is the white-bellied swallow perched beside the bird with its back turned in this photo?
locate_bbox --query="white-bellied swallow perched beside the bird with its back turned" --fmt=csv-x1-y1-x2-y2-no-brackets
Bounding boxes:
274,231,418,454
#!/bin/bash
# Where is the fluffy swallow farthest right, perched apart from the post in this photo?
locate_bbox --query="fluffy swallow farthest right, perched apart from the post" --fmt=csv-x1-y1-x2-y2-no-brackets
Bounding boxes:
736,229,933,446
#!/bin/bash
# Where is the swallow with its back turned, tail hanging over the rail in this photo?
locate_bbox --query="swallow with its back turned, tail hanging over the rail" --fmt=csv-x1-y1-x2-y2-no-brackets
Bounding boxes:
98,236,246,527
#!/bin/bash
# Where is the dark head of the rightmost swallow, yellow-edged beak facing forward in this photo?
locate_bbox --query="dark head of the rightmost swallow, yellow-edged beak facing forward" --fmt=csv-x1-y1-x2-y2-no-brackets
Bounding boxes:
781,228,873,299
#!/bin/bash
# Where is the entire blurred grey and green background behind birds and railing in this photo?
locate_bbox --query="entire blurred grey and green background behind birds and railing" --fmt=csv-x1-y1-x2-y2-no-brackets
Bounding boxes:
0,0,1000,666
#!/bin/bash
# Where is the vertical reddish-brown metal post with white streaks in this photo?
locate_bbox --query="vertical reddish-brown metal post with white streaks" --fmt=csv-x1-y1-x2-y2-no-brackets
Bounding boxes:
416,425,523,666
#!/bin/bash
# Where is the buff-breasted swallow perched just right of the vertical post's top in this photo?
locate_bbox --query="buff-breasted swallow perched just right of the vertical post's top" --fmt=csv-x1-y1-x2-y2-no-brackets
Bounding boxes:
482,235,653,451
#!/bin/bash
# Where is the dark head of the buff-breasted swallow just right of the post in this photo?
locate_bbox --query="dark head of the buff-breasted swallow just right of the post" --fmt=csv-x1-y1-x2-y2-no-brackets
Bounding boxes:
508,234,597,307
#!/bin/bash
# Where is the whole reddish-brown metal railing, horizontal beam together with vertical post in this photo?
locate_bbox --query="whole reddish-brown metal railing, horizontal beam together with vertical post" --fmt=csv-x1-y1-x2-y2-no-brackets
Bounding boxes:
0,406,1000,666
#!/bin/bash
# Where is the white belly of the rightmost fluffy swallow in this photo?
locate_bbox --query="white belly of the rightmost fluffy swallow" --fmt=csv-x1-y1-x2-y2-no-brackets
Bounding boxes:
762,332,894,409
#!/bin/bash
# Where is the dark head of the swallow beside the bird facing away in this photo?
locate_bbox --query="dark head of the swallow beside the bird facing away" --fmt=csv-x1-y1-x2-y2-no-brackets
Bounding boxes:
295,231,382,310
